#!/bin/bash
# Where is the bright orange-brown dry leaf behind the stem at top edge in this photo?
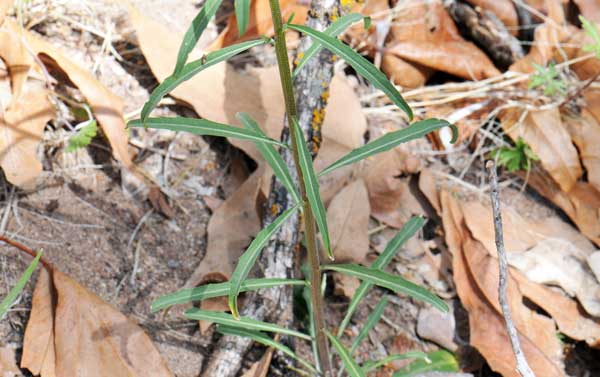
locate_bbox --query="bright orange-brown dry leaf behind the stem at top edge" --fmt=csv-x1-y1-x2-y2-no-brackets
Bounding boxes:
207,0,308,51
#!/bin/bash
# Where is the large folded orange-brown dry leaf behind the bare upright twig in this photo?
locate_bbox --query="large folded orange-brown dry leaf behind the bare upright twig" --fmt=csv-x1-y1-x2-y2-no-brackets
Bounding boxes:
440,190,563,377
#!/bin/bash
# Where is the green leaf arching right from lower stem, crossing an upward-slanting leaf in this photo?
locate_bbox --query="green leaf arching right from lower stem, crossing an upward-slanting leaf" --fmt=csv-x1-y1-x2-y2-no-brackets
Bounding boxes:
322,264,448,312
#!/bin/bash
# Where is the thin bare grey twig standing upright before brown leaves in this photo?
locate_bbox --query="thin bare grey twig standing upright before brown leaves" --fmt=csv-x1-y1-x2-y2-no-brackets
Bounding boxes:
485,160,535,377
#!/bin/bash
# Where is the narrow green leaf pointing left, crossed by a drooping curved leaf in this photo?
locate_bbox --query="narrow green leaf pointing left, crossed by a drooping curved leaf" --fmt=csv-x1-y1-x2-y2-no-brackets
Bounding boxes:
151,279,306,312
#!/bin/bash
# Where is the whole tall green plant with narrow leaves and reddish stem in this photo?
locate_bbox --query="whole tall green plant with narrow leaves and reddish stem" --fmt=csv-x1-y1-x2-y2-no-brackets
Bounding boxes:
134,0,458,376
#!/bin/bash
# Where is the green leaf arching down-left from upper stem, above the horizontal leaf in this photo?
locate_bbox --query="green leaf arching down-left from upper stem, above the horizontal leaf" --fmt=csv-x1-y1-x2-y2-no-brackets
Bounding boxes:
141,38,269,120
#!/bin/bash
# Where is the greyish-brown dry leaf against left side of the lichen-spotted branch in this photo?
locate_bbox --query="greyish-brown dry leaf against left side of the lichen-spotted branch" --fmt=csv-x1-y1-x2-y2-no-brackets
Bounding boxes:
186,169,265,287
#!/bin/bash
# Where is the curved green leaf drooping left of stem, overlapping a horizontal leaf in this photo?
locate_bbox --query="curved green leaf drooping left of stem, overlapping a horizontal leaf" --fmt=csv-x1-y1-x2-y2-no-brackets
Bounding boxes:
229,204,300,318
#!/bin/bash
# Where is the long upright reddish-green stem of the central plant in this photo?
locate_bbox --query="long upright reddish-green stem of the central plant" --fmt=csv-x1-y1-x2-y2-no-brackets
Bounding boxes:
269,0,333,377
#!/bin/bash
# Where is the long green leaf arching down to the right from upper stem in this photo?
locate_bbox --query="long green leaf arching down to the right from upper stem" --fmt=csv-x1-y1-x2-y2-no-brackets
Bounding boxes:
288,25,413,120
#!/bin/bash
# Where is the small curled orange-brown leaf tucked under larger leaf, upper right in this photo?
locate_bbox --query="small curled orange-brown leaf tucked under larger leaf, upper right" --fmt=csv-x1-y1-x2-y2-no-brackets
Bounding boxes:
381,53,434,89
